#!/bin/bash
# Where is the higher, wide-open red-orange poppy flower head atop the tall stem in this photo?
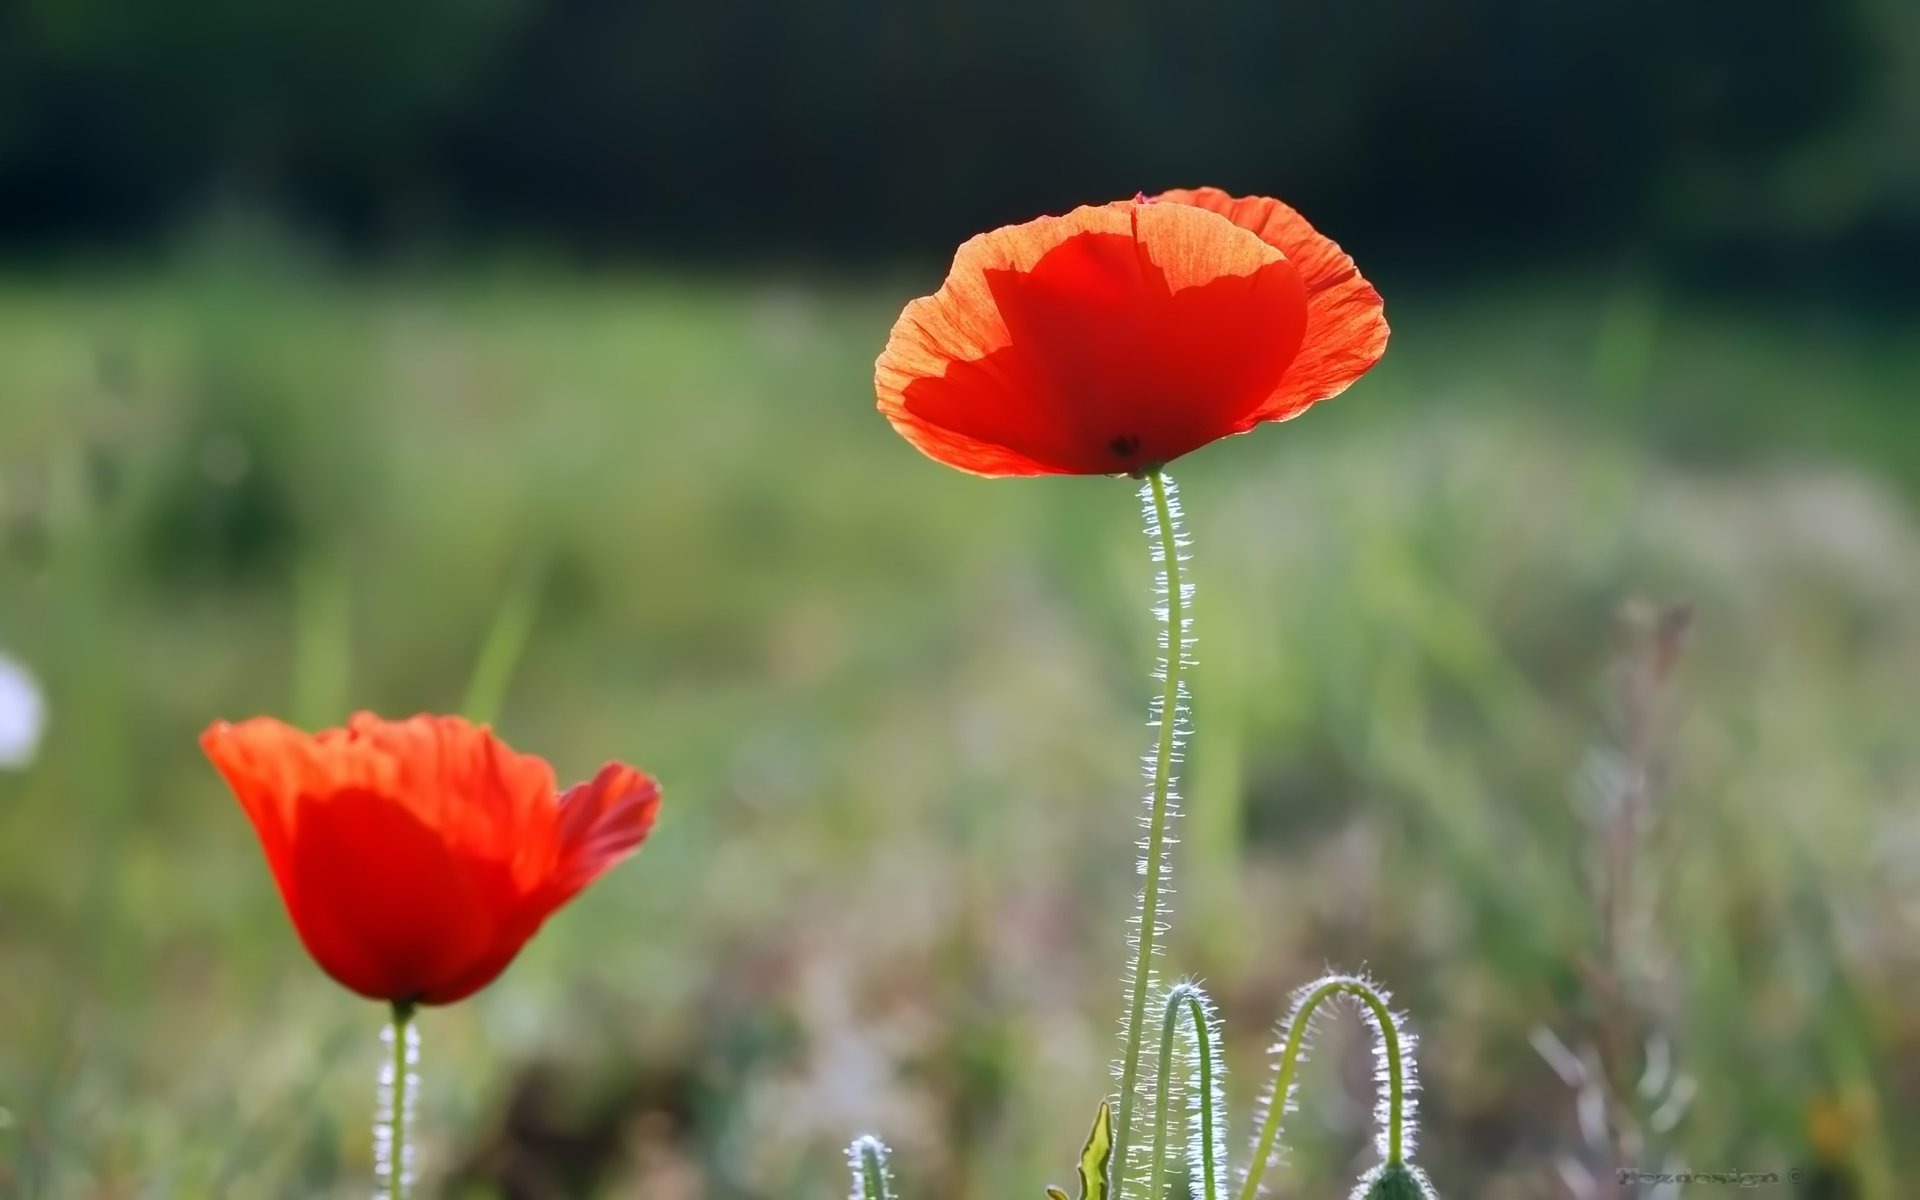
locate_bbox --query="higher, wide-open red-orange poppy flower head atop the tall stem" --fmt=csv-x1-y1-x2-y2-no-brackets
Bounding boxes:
874,188,1386,474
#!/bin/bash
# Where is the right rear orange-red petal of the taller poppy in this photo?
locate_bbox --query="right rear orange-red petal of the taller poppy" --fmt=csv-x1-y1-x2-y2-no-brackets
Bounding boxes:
1160,188,1388,420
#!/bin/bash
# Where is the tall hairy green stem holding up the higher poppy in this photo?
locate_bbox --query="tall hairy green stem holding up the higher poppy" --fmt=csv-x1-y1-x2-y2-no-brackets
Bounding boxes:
1112,470,1187,1200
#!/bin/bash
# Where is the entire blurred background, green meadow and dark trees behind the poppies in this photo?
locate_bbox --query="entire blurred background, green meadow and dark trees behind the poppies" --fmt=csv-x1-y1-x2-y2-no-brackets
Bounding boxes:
0,0,1920,1200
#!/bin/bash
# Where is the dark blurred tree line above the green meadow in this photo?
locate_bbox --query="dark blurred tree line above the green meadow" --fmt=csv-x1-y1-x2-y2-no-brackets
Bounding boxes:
0,0,1920,276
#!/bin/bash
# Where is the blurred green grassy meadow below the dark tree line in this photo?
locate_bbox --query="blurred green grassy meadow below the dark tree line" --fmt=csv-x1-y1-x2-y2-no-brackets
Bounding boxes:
0,244,1920,1200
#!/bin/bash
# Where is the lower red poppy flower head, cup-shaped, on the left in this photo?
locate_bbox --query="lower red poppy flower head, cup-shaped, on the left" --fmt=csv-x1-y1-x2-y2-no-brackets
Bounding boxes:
200,712,660,1004
